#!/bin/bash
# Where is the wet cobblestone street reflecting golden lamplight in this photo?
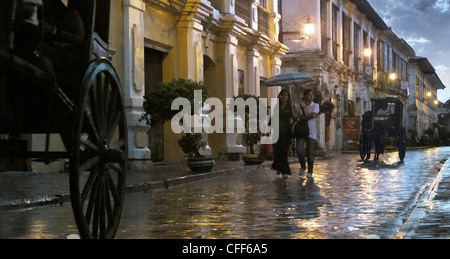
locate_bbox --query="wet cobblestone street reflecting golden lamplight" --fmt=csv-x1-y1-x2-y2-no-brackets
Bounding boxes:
0,147,450,238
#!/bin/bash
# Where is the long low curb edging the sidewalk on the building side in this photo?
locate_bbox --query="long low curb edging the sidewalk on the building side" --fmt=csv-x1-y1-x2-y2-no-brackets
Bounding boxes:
0,154,333,212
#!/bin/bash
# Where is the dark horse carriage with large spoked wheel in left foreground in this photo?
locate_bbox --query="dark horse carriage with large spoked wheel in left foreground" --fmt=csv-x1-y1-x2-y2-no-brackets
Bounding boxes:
0,0,128,238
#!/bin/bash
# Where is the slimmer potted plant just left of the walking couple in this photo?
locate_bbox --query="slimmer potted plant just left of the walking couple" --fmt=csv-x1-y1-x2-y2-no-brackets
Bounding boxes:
234,94,264,165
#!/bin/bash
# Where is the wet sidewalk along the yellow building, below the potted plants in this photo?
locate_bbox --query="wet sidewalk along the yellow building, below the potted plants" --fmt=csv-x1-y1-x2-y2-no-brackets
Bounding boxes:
0,158,282,211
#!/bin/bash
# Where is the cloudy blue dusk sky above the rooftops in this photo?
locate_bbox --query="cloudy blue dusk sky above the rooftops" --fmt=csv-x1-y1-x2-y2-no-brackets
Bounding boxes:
369,0,450,102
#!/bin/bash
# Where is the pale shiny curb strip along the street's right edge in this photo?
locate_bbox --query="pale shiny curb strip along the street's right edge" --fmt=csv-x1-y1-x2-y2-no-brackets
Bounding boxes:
393,158,450,239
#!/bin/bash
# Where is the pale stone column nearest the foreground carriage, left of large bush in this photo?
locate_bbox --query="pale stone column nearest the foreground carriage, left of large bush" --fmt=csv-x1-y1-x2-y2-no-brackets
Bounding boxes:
122,0,151,169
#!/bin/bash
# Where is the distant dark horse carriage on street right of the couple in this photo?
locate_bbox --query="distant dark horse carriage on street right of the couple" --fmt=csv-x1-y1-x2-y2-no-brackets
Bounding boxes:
359,92,406,161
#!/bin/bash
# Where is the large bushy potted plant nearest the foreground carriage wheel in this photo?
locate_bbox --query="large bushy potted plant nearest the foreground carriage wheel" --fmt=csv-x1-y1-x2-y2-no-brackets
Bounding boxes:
141,79,214,172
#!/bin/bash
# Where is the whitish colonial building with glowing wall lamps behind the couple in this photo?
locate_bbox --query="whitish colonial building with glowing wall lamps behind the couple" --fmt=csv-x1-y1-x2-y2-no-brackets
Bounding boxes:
280,0,440,150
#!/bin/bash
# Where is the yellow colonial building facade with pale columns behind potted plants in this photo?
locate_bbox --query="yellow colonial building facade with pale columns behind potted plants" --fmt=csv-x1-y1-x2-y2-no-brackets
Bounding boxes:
110,0,287,167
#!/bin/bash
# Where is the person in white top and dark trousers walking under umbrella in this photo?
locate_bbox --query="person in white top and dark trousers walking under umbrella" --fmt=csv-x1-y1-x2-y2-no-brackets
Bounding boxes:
297,89,320,179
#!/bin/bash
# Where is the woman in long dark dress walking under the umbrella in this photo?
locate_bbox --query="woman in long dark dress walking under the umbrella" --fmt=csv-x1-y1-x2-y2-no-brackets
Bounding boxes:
272,90,298,179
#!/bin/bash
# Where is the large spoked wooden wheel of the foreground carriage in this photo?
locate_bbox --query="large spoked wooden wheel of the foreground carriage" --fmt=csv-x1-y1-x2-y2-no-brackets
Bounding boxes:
70,59,127,238
